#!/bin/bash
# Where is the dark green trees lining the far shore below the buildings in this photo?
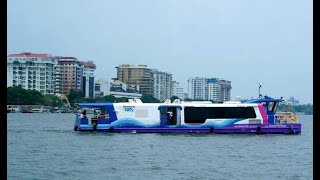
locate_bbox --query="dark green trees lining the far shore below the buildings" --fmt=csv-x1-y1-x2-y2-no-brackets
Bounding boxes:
7,86,313,114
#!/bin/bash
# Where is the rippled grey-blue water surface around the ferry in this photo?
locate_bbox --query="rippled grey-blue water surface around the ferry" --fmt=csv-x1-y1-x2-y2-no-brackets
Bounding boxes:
7,113,313,180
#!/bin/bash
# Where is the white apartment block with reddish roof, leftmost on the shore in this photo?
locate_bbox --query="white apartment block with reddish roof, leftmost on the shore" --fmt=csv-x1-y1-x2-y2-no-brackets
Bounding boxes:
7,52,58,94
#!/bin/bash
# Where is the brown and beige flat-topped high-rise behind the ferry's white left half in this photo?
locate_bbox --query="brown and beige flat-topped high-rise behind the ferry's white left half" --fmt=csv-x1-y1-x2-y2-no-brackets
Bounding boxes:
116,64,154,96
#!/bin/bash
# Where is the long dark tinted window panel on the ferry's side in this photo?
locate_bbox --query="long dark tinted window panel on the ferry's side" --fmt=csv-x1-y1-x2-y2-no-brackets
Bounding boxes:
184,107,256,123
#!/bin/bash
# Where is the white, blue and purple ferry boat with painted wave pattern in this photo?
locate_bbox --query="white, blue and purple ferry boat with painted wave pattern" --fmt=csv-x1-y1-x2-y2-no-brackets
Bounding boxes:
74,96,301,134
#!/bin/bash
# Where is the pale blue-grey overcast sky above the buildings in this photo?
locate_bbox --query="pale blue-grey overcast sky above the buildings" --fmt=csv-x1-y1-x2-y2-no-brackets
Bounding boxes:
7,0,313,104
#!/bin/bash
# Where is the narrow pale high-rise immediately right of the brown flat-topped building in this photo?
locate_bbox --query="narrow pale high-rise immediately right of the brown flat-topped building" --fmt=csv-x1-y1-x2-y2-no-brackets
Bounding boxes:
151,69,172,101
